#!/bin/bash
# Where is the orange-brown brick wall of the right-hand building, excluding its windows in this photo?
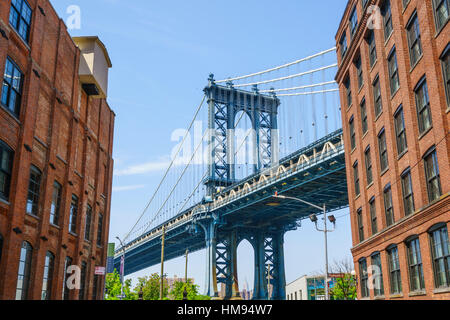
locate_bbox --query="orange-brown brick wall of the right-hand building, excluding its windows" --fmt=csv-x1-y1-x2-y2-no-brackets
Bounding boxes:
336,0,450,299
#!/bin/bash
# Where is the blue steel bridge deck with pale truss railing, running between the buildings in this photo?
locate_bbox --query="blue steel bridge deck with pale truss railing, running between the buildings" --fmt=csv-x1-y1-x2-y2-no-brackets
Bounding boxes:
114,130,348,274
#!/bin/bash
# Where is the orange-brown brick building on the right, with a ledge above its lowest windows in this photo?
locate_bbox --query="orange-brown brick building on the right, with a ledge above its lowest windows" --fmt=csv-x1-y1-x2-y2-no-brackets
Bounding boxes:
336,0,450,299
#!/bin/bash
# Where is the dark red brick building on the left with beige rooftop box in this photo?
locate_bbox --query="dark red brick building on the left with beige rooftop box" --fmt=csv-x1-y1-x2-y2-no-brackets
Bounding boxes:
0,0,115,300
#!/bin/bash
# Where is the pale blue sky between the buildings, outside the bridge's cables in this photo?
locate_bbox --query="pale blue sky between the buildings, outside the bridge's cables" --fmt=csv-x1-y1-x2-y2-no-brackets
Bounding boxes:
51,0,351,288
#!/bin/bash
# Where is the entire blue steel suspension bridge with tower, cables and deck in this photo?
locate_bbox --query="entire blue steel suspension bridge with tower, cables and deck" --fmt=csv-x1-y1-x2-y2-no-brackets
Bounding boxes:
114,48,348,300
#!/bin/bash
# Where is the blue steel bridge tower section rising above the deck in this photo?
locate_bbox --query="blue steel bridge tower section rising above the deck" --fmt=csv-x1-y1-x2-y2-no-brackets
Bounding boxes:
204,74,280,196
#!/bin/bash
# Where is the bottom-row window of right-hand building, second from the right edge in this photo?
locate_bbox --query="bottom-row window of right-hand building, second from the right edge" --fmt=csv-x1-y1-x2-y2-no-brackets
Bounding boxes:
406,238,425,292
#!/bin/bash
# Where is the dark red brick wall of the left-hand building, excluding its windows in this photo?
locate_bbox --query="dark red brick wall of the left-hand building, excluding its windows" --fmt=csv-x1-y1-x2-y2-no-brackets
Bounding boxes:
0,0,115,299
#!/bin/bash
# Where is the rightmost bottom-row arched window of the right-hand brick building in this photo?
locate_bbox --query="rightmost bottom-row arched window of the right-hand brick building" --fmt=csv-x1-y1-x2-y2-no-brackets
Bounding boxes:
430,225,450,288
